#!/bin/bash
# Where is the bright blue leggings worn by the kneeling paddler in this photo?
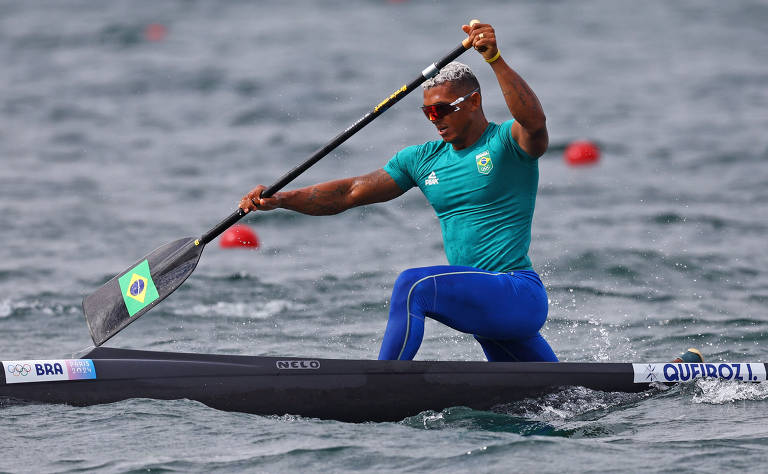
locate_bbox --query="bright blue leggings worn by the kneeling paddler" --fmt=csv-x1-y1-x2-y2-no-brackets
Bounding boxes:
379,265,557,362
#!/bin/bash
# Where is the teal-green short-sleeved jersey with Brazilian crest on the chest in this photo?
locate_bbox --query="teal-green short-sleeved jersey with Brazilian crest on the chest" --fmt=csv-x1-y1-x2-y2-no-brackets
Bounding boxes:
384,120,539,272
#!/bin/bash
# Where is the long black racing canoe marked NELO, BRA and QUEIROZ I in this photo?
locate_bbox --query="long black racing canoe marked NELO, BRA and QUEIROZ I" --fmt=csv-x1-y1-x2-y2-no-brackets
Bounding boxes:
0,347,766,422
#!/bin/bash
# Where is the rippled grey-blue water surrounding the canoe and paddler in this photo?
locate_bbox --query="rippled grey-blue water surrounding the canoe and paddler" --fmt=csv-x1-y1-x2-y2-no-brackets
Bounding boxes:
0,0,768,472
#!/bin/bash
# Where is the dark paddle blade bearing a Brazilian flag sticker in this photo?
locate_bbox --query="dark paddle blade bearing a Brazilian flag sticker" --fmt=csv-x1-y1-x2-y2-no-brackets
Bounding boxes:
83,237,204,346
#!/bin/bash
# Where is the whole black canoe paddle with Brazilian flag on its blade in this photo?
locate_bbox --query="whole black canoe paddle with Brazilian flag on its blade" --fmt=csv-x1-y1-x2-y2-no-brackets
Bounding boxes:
83,20,478,346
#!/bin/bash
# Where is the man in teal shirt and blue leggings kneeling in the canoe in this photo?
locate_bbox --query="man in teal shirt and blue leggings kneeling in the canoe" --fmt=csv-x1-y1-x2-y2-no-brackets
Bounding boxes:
240,23,557,361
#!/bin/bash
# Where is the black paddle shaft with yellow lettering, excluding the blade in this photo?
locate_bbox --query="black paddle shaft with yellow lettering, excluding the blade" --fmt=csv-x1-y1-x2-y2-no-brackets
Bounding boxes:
199,39,471,245
